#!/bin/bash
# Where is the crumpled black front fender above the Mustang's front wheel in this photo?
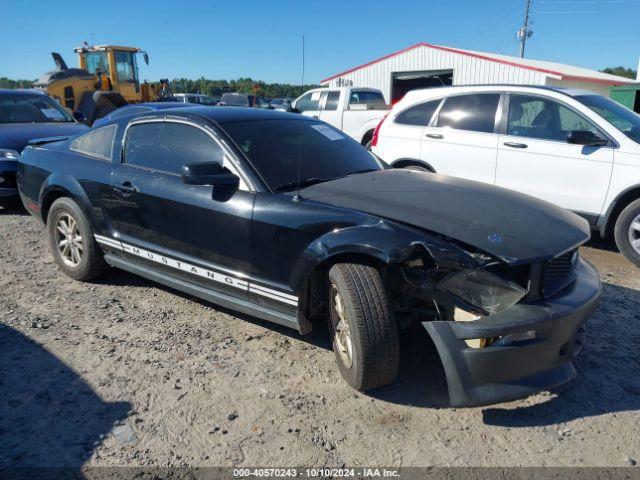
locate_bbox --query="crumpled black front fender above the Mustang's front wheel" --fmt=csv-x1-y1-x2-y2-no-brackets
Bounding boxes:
289,220,475,292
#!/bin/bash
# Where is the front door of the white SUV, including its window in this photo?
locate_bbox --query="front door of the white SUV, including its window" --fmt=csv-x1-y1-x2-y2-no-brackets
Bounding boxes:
496,94,613,215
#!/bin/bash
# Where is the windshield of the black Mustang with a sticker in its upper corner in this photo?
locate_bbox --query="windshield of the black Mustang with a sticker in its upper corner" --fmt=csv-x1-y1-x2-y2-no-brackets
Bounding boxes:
222,120,384,191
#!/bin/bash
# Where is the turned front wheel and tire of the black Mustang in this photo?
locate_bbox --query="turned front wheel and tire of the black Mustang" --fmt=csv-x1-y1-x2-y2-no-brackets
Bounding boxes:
328,263,400,391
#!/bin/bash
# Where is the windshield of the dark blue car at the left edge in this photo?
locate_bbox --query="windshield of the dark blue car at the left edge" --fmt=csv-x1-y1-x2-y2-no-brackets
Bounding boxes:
0,94,75,123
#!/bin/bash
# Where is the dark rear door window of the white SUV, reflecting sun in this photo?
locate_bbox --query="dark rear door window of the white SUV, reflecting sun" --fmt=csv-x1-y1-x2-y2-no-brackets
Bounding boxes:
437,93,500,133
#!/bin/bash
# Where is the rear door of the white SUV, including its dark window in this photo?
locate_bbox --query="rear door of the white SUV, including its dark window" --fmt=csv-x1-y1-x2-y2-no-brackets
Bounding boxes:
420,93,501,183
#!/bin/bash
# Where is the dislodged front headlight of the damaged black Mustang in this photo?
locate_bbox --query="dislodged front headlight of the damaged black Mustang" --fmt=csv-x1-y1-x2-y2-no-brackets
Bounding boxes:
436,270,527,315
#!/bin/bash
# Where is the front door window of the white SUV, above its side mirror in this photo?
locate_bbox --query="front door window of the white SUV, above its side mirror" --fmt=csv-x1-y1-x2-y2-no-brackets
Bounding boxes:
507,95,598,142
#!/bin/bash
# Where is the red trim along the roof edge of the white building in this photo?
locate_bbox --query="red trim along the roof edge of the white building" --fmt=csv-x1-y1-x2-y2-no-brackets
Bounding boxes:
320,42,634,85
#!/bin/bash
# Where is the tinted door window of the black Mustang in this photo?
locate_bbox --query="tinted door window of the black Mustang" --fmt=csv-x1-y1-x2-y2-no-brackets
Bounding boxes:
125,122,223,175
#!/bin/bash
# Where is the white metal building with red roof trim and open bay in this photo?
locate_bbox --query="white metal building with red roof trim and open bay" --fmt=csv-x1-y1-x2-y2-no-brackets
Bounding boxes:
320,43,636,102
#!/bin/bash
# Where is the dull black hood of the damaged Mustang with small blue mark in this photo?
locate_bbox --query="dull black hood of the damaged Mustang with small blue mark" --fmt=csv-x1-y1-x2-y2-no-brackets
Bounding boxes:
301,169,590,264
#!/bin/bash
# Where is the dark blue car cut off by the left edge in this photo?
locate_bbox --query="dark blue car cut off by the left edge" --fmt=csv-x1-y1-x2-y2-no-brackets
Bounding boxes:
0,89,89,207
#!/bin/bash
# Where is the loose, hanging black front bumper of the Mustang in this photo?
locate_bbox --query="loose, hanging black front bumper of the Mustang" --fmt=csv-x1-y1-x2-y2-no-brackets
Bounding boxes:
422,260,602,407
